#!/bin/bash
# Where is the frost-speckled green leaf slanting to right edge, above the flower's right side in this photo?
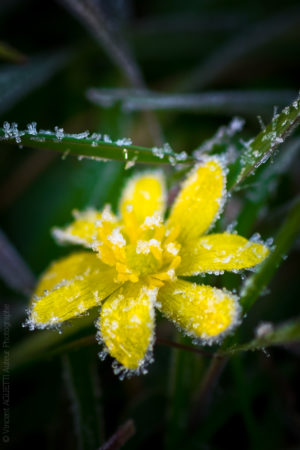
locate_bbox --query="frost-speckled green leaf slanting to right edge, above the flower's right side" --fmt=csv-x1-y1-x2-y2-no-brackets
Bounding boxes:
229,97,300,189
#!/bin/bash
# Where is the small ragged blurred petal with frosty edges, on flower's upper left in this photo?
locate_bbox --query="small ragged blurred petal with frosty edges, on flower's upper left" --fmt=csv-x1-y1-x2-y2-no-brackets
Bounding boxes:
53,206,117,248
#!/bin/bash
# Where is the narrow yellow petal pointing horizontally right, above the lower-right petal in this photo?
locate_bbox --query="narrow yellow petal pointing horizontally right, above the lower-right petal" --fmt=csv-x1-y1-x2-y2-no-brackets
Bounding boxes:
177,233,269,275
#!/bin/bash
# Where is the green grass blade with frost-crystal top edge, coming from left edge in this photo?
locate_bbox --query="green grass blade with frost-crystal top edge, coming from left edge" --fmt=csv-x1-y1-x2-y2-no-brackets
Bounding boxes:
0,122,193,167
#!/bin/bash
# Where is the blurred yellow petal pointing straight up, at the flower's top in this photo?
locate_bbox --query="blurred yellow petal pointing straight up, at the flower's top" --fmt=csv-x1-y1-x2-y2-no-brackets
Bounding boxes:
119,172,166,236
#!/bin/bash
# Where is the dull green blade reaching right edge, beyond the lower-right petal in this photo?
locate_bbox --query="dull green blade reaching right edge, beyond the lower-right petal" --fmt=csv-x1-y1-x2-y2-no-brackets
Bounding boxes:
222,319,300,355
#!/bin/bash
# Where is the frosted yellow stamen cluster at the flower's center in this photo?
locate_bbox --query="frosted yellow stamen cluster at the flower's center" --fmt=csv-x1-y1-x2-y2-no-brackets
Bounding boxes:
96,214,181,287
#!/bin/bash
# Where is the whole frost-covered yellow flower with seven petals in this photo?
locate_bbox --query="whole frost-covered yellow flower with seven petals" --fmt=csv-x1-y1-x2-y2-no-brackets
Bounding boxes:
28,157,269,371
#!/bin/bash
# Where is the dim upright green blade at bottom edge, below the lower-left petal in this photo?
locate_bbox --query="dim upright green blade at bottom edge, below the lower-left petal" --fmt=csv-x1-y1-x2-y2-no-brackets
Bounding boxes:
63,348,103,450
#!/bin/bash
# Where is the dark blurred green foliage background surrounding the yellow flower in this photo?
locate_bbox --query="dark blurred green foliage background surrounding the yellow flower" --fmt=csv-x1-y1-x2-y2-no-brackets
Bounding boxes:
0,0,300,450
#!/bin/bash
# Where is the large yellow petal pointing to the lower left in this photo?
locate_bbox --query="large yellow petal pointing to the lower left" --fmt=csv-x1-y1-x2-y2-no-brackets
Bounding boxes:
27,252,119,328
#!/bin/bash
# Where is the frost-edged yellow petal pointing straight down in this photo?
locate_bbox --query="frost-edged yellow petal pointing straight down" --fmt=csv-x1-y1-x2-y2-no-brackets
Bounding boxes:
98,282,157,370
